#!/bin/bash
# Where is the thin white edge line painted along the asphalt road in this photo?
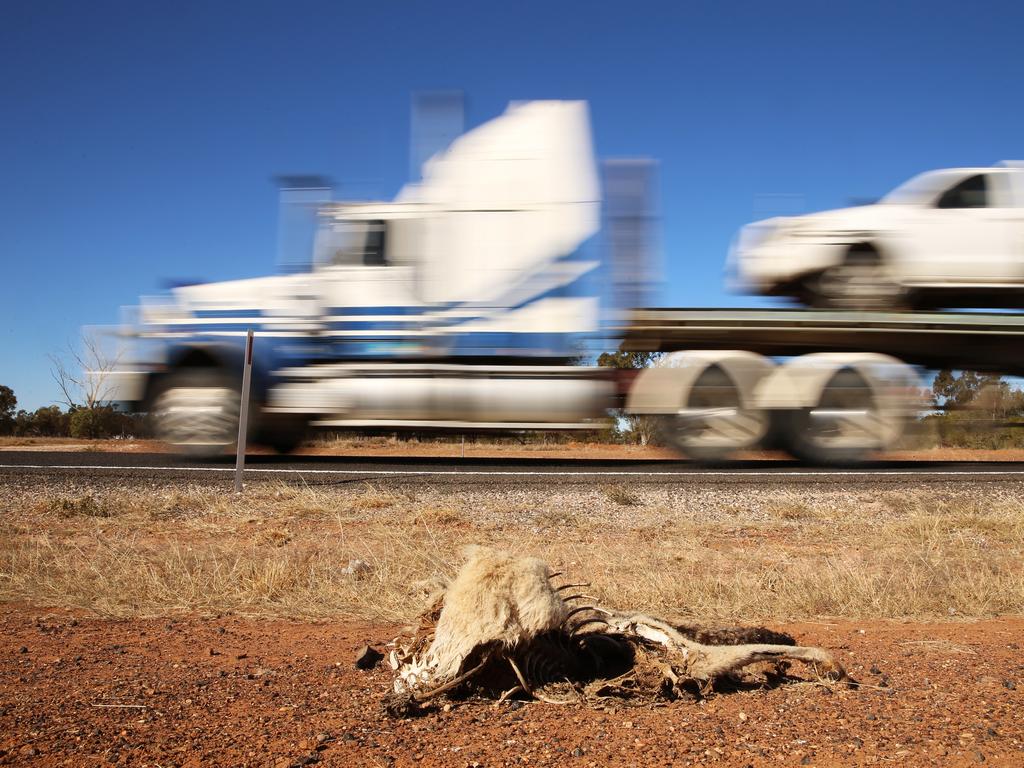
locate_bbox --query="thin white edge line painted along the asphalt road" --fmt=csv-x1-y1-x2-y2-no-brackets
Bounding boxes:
0,464,1024,477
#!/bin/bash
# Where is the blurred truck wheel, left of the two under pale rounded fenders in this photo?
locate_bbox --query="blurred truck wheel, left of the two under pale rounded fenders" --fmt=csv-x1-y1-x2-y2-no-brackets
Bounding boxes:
660,366,768,463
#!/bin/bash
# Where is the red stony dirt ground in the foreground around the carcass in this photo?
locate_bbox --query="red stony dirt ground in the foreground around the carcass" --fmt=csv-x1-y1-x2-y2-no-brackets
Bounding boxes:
0,606,1024,768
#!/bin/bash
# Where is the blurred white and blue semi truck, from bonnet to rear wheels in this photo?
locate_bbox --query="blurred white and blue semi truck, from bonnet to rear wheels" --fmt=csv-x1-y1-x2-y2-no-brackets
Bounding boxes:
114,101,937,463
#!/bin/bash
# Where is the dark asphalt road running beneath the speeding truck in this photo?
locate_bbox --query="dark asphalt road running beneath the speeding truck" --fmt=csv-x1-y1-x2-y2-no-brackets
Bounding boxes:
0,451,1024,485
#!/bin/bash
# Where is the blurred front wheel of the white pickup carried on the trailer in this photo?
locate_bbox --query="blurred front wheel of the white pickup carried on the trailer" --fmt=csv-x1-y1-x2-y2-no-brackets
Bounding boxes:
808,243,907,309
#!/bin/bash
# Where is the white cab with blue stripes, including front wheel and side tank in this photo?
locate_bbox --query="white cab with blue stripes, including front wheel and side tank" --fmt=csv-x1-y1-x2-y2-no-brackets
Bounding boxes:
111,101,611,456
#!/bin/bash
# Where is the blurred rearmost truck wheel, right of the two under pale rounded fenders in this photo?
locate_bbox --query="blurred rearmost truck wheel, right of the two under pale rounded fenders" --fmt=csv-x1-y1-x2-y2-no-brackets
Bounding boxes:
775,368,892,466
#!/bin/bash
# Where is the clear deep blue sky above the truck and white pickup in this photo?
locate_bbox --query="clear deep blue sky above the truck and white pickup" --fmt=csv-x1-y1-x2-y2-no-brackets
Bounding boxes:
0,0,1024,409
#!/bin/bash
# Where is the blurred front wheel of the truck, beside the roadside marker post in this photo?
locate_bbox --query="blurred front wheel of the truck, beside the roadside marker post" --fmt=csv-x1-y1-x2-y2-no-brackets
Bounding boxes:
151,368,241,459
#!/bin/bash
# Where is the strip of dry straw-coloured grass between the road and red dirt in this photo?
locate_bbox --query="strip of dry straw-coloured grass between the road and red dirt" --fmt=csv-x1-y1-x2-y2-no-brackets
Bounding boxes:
0,484,1024,621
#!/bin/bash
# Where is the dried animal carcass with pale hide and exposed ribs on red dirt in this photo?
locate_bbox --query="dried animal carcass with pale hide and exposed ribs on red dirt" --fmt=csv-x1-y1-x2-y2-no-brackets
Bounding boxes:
386,547,846,715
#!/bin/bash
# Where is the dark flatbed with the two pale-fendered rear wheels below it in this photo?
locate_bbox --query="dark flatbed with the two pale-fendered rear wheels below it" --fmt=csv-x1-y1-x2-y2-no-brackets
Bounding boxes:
620,308,1024,464
